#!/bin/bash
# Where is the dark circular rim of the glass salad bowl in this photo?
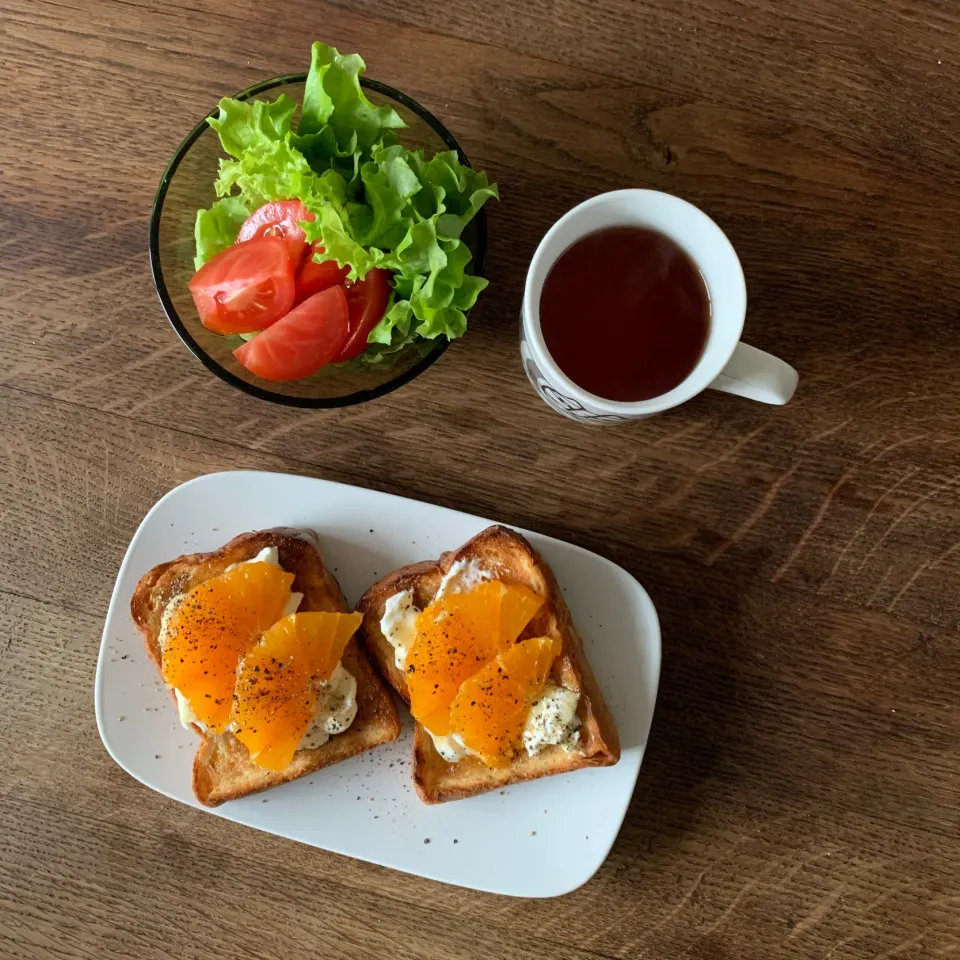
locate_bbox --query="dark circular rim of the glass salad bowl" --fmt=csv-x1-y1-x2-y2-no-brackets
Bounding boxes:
148,73,487,409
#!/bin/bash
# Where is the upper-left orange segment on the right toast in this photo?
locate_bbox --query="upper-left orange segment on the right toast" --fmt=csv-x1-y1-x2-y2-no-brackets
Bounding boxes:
404,580,543,736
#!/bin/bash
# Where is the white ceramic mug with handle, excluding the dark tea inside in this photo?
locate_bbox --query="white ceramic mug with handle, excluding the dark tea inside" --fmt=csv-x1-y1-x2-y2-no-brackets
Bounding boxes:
520,190,797,423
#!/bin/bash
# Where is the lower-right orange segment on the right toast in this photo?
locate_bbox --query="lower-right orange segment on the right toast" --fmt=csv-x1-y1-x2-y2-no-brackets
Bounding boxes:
450,637,560,767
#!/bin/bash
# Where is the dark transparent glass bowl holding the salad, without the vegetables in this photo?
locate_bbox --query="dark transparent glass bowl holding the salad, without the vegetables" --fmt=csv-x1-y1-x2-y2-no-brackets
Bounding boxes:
150,73,487,407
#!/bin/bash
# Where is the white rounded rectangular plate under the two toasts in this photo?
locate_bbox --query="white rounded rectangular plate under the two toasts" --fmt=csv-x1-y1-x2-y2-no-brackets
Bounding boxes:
96,471,660,897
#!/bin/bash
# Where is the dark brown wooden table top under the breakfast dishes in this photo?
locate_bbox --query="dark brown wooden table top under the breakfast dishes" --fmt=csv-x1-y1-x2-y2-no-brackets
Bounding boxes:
0,0,960,960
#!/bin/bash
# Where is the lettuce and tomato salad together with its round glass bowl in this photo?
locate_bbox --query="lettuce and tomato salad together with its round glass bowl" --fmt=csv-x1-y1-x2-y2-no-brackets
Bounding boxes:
151,42,497,406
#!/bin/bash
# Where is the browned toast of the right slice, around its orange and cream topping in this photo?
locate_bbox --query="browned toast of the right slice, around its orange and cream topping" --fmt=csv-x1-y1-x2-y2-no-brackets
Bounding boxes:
357,526,620,803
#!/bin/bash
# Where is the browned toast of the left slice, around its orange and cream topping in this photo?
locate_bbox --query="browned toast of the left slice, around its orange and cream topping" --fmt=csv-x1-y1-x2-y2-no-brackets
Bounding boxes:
130,528,400,807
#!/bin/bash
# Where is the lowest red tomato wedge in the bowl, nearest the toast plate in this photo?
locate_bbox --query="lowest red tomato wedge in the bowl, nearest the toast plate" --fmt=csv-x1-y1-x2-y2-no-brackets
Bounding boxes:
233,287,350,380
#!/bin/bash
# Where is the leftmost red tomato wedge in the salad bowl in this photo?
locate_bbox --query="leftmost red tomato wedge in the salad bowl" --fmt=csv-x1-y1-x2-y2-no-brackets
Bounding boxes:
188,237,294,333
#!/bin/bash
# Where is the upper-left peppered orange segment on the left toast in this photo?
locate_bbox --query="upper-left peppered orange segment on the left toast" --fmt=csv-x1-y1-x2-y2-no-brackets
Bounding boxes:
162,563,294,732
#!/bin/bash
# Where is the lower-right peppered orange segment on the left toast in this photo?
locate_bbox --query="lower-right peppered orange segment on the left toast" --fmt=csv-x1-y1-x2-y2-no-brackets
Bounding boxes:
230,612,363,770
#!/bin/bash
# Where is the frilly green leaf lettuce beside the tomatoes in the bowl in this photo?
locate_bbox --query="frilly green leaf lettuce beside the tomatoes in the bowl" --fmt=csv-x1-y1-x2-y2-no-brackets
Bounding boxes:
196,42,498,362
